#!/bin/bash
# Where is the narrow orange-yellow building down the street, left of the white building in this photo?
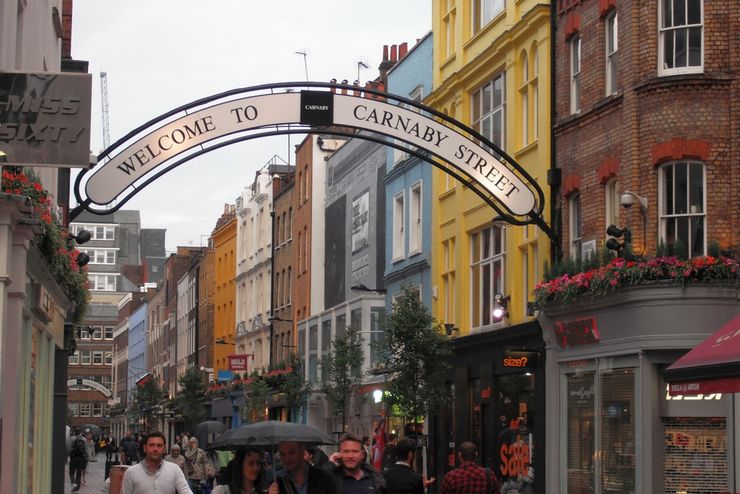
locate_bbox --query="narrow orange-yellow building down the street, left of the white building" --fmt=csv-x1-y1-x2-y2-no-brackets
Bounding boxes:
211,205,236,376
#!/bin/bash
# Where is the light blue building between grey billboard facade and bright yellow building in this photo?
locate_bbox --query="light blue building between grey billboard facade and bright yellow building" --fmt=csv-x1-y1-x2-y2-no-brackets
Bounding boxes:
383,32,433,310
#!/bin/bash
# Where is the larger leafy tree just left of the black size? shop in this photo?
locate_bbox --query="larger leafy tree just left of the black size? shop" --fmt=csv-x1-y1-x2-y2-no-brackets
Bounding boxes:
378,287,453,420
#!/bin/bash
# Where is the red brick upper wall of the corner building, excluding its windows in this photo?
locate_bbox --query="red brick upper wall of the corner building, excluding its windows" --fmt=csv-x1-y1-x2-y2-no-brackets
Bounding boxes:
554,0,740,255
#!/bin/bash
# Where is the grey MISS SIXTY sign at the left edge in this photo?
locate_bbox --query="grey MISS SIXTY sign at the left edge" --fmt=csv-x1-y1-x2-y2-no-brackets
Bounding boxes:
0,72,92,168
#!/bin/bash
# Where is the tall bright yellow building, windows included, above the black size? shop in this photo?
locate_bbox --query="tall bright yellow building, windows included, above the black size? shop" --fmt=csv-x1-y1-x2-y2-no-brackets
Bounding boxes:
424,0,550,336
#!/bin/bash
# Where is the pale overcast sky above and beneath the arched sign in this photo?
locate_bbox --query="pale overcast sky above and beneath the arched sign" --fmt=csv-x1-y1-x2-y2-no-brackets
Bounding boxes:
72,0,431,251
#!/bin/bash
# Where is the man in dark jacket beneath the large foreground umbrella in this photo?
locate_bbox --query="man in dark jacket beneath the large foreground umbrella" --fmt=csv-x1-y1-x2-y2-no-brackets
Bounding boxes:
275,441,338,494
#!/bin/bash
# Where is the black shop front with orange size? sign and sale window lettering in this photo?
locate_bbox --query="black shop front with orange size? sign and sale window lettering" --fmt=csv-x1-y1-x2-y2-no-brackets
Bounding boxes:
430,321,546,493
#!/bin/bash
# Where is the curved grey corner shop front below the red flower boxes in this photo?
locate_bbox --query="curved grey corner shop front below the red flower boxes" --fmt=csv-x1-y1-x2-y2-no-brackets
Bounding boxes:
539,286,739,494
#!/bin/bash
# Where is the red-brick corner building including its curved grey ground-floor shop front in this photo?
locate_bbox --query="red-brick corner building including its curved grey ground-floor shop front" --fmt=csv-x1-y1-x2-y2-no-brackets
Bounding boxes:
539,0,740,494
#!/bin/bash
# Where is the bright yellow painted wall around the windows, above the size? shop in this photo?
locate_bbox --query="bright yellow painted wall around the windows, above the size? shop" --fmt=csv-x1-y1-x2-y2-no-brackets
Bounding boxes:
424,0,551,336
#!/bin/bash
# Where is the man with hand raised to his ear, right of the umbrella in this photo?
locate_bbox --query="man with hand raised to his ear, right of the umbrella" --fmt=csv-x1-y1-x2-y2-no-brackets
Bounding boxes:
329,433,386,494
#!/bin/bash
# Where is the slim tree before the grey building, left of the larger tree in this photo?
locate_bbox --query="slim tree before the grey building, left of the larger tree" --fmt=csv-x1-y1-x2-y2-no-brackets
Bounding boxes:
321,328,364,430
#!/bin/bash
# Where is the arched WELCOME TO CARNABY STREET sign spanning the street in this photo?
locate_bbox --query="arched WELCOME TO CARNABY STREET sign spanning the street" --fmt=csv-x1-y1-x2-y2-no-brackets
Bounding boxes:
70,82,550,235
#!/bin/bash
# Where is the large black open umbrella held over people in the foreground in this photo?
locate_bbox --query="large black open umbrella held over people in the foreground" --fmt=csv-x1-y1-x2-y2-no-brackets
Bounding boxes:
211,420,333,449
